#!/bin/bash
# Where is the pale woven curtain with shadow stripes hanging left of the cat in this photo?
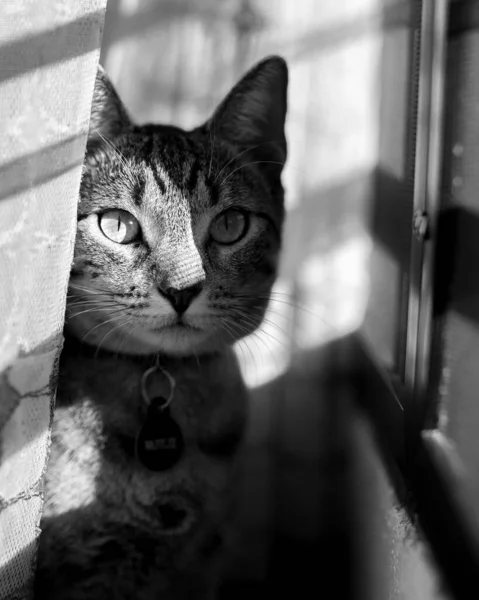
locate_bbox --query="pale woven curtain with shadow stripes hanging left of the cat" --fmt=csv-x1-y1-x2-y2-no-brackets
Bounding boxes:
0,0,106,600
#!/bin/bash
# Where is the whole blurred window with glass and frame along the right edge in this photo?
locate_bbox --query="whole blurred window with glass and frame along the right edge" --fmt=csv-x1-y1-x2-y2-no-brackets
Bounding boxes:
358,0,479,598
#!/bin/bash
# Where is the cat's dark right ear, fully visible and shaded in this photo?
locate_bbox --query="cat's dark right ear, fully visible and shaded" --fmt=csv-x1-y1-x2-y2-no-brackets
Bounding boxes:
206,56,288,174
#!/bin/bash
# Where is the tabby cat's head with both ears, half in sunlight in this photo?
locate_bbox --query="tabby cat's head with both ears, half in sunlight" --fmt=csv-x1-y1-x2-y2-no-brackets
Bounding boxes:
67,57,287,355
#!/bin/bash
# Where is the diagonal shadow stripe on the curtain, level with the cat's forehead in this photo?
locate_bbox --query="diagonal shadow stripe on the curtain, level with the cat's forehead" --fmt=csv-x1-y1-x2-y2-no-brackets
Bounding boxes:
0,133,86,200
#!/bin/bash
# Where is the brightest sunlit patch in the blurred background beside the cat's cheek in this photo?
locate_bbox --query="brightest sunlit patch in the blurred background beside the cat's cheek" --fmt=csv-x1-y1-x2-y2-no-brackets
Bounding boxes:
235,233,372,387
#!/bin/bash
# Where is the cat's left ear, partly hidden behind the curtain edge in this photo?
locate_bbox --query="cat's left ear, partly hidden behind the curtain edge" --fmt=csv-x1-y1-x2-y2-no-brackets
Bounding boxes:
88,65,132,145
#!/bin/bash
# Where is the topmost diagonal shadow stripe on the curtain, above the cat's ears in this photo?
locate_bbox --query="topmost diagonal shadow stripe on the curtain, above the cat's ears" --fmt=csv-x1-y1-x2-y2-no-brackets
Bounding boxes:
0,10,105,83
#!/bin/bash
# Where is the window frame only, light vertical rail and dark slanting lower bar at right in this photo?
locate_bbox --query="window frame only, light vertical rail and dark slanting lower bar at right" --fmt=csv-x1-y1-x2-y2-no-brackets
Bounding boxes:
351,0,479,598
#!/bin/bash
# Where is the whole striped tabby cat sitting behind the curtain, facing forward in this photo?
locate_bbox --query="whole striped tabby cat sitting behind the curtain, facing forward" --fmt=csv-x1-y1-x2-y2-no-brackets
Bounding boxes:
35,56,288,600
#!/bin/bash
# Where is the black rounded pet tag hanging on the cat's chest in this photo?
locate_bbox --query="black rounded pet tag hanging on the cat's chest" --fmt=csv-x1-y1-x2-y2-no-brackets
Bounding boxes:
136,396,184,471
